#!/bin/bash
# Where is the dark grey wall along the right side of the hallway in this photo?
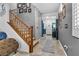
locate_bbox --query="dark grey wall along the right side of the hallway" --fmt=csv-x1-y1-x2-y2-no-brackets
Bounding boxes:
59,3,79,56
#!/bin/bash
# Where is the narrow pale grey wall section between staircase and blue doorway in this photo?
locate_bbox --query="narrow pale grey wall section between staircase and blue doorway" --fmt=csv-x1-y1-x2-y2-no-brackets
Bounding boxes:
35,8,41,39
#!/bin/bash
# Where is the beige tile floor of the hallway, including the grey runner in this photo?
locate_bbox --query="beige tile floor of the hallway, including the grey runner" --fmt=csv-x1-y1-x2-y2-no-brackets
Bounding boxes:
14,36,65,56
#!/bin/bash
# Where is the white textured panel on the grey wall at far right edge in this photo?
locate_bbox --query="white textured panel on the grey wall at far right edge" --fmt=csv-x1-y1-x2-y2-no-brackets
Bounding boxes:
72,3,79,38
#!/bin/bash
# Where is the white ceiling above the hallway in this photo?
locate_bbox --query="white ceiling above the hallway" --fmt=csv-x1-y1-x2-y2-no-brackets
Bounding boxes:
33,3,60,13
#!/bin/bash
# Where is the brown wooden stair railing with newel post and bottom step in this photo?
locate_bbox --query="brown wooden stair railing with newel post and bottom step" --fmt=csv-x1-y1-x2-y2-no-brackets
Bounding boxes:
8,10,39,53
